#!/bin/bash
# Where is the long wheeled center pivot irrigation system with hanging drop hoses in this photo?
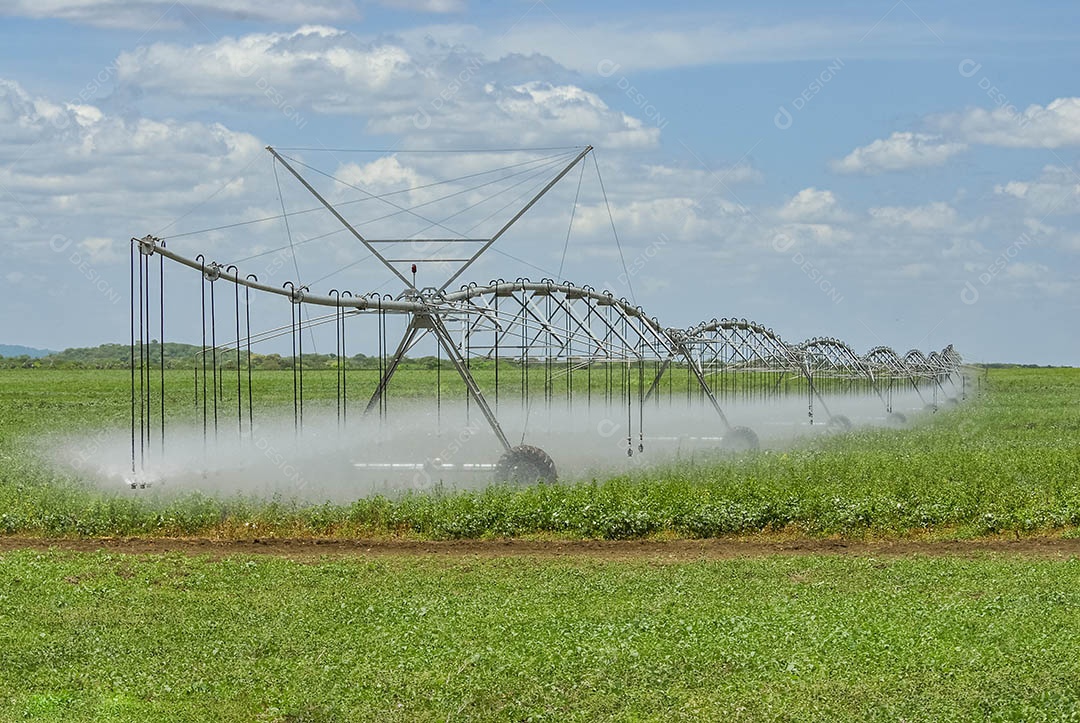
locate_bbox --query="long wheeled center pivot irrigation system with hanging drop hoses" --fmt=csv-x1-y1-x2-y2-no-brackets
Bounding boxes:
131,146,966,486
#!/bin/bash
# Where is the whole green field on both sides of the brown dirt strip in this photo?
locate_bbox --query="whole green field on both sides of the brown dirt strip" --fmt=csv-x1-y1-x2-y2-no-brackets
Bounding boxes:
0,370,1080,723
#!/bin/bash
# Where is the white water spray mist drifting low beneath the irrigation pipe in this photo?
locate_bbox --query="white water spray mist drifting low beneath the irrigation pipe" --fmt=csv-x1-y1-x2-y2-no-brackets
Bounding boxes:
52,392,937,503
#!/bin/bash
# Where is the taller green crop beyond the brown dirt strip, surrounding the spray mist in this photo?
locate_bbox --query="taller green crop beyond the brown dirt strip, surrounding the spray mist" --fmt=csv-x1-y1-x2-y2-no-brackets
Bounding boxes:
0,370,1080,539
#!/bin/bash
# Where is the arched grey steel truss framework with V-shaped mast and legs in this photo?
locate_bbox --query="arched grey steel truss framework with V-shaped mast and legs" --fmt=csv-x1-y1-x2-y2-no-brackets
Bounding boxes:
131,147,963,479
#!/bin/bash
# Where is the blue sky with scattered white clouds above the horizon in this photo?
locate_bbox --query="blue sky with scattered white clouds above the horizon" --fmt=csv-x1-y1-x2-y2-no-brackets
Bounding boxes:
0,0,1080,364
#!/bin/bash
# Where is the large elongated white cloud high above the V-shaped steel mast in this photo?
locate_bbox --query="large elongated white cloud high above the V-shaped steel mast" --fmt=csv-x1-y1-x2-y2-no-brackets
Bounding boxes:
117,25,661,148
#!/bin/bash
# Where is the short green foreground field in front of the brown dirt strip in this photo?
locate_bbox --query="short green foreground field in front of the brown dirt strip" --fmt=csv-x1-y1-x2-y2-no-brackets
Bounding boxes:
0,551,1080,722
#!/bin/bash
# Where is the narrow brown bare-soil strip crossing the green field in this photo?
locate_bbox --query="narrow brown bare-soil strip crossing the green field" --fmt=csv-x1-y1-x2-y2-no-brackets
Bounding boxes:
0,537,1080,562
